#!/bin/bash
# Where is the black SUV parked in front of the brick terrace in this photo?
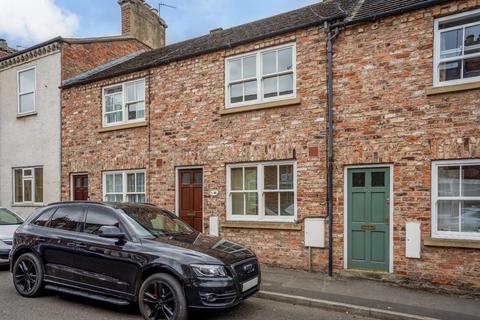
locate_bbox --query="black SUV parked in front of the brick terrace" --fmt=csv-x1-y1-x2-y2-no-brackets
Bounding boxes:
10,202,260,319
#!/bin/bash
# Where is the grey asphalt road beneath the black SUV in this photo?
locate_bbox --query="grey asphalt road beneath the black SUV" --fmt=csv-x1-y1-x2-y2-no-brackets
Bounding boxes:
0,268,366,320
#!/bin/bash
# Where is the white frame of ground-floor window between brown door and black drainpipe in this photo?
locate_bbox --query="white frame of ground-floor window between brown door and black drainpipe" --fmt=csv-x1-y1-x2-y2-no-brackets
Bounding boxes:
226,160,297,222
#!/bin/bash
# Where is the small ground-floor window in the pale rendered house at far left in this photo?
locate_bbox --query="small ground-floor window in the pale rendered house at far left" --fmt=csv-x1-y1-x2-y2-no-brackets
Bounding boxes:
13,167,43,204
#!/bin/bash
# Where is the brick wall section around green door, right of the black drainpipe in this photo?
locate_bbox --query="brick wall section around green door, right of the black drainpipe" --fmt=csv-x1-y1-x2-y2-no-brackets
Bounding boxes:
334,1,480,292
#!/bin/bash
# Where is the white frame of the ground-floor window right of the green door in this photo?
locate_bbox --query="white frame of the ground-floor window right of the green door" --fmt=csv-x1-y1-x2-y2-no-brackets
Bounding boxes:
431,160,480,240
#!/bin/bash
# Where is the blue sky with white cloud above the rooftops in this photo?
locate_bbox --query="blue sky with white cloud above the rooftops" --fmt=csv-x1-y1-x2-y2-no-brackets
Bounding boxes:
0,0,319,49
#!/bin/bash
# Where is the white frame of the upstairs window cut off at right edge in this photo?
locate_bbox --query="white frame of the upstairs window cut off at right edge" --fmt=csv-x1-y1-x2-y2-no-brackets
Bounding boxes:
433,9,480,87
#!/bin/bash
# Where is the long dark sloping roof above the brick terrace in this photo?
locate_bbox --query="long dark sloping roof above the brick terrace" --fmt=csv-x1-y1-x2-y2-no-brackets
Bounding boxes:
64,0,448,87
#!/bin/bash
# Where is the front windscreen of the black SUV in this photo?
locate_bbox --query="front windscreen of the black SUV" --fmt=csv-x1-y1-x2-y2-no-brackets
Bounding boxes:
120,206,194,237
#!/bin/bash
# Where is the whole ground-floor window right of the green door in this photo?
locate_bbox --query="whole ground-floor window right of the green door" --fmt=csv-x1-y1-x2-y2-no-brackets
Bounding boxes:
432,160,480,240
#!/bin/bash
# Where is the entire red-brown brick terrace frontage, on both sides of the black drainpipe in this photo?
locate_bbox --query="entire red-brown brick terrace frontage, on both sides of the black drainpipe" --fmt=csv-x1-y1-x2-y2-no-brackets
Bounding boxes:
62,1,480,292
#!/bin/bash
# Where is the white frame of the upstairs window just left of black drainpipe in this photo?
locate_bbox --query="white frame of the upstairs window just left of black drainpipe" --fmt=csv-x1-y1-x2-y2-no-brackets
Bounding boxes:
225,42,297,108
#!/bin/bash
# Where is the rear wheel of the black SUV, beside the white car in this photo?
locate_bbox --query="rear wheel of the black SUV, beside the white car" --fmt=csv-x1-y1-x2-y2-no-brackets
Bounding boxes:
12,253,43,297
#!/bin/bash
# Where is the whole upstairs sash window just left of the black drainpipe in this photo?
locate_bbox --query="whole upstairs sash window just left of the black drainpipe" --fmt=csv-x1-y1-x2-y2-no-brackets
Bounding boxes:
225,44,296,108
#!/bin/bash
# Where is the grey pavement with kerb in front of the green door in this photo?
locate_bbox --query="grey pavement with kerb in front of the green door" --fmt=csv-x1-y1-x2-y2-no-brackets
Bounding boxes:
257,266,480,320
